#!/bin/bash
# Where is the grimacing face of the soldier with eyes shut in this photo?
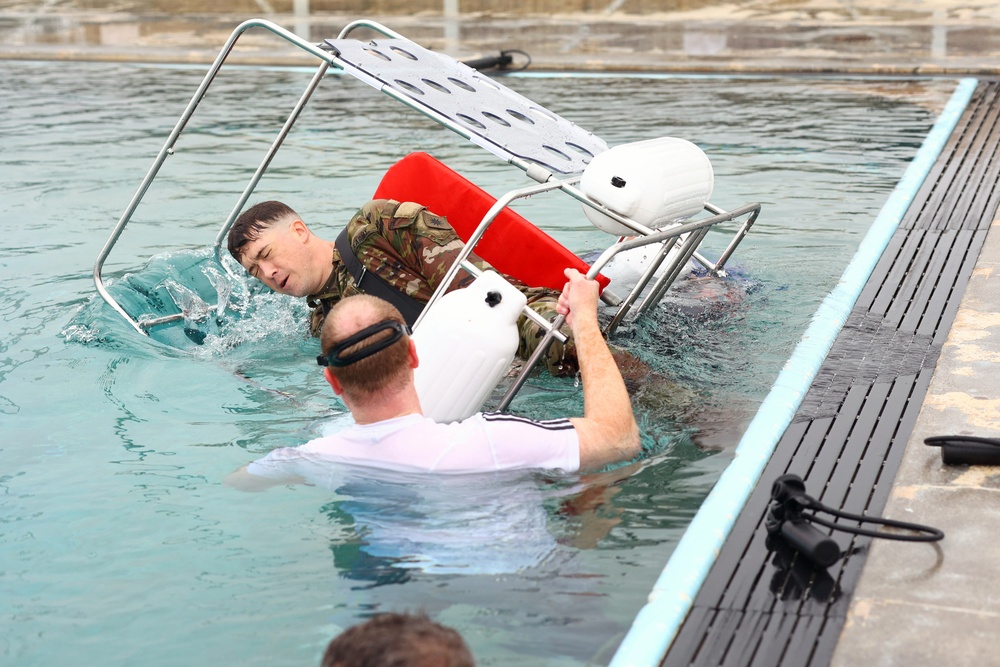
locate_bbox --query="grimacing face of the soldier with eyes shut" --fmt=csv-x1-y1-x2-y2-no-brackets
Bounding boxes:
240,220,330,296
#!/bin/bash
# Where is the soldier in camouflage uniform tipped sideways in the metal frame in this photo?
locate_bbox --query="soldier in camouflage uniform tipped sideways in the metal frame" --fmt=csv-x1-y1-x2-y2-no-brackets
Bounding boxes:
229,199,577,375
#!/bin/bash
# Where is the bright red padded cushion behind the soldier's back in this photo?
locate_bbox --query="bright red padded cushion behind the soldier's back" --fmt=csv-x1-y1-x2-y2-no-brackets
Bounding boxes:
374,153,610,290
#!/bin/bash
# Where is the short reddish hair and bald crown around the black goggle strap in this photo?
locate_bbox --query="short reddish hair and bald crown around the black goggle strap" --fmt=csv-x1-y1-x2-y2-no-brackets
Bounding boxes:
320,294,410,397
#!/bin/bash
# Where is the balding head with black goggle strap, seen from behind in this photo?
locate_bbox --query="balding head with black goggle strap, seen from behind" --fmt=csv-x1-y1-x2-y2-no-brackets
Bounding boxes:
320,294,415,399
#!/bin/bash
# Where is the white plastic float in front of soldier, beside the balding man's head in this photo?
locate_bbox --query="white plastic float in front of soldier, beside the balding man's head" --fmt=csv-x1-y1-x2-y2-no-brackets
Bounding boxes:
413,271,526,423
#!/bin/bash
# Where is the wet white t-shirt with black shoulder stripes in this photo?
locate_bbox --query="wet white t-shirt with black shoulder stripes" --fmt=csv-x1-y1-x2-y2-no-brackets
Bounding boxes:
247,413,580,477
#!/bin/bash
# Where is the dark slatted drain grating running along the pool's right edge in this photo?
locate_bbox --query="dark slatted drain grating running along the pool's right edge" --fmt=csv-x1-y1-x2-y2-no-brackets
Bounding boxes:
663,82,1000,667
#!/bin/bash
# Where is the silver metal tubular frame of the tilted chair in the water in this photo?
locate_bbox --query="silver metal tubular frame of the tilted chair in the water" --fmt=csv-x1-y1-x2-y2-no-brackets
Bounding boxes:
94,19,760,410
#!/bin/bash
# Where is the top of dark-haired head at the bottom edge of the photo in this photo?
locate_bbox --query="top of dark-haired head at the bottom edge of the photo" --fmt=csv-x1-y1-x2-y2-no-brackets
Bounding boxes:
321,613,476,667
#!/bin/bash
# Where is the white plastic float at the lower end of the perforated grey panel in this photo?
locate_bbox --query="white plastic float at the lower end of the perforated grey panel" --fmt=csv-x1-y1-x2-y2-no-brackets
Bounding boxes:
580,137,715,235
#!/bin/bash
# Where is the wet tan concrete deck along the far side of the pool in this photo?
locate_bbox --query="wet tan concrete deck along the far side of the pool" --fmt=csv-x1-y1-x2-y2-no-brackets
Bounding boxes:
0,0,1000,76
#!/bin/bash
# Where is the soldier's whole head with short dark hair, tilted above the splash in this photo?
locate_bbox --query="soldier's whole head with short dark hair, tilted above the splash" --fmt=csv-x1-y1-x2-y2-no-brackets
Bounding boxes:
228,201,333,296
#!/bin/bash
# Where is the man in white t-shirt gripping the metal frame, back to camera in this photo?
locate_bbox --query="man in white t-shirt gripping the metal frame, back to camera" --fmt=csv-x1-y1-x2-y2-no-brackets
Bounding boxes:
227,269,640,490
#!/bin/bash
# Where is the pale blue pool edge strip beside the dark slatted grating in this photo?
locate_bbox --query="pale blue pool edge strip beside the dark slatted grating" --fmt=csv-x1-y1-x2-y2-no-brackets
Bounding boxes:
610,78,977,667
